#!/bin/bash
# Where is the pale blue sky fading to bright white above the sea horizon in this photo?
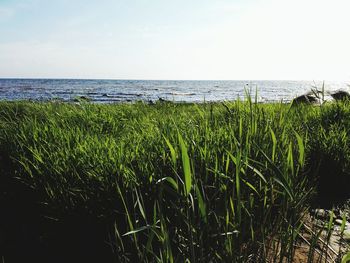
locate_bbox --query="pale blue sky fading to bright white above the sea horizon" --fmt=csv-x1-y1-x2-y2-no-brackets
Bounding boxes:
0,0,350,81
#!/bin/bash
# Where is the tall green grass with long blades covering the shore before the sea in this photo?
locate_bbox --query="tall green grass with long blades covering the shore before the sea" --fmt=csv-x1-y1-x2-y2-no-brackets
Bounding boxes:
0,96,350,262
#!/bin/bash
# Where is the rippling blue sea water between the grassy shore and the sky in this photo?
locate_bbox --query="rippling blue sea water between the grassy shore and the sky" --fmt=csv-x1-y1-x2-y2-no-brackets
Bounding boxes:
0,79,349,103
